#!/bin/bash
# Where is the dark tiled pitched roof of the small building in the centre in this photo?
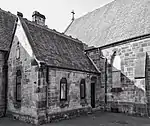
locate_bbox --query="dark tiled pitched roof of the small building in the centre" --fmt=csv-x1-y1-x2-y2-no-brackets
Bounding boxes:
20,18,98,73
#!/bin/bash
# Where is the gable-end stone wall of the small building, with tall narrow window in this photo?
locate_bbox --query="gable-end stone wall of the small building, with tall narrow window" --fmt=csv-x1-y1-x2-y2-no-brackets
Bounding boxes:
7,34,39,124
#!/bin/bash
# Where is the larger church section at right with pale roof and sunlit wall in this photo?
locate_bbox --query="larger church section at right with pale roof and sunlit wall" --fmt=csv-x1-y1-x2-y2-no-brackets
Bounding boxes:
65,0,150,116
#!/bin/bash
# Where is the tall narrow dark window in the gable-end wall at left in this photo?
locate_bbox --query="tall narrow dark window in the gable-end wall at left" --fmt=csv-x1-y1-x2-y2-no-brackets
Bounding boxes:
16,70,21,102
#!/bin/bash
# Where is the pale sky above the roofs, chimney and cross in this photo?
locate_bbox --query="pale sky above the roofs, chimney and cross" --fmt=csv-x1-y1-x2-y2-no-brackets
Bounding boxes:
0,0,112,32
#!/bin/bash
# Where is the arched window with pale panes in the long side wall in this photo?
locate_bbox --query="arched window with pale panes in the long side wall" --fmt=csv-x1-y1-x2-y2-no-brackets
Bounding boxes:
60,78,67,100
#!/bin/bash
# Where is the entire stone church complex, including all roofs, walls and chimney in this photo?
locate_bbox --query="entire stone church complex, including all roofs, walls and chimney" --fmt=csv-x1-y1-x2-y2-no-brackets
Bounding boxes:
0,0,150,124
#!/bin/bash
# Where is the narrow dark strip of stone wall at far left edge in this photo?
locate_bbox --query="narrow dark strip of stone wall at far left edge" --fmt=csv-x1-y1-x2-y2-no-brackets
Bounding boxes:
0,51,6,117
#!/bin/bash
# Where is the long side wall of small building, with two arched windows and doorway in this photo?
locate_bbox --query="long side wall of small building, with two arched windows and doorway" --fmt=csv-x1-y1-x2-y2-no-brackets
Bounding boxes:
38,68,100,124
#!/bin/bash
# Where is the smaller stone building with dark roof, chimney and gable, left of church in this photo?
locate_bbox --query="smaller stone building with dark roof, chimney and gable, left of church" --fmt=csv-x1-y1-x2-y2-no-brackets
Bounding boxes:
0,10,100,124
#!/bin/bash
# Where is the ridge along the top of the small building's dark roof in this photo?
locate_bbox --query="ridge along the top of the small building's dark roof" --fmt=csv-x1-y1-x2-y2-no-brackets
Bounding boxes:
23,18,84,44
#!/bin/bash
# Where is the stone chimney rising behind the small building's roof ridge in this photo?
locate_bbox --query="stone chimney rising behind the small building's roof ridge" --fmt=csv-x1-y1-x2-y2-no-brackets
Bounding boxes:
32,11,46,26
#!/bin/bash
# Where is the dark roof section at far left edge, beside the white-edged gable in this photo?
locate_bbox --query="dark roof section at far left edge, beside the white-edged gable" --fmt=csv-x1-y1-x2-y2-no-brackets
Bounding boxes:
0,9,17,51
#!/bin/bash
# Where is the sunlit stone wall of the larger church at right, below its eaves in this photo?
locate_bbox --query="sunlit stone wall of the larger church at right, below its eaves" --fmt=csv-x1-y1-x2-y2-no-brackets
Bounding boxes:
87,38,150,115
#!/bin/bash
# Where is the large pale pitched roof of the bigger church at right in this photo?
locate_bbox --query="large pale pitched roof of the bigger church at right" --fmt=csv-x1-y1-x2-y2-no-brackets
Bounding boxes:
66,0,150,46
